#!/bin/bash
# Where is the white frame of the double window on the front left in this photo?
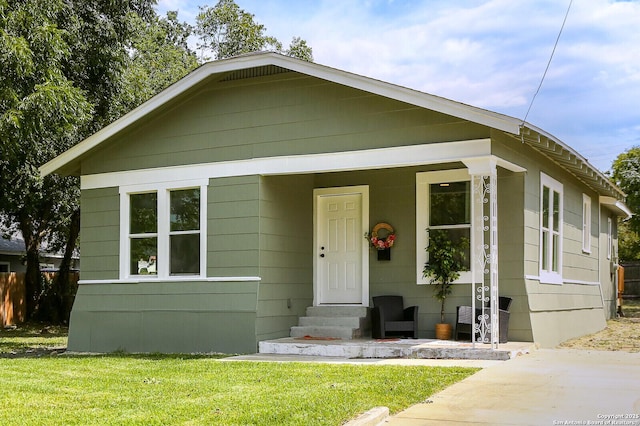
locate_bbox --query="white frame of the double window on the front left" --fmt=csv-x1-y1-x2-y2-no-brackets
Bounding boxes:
120,179,209,281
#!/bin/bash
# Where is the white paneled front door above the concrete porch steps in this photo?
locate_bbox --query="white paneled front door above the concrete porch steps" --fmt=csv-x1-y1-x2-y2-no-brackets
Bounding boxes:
314,187,369,306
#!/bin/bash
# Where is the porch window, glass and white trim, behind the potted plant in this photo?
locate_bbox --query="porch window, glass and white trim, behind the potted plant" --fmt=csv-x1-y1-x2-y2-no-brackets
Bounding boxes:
416,169,471,284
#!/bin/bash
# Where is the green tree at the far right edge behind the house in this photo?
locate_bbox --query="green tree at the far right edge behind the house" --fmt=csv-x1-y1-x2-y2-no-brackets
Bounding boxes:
611,146,640,260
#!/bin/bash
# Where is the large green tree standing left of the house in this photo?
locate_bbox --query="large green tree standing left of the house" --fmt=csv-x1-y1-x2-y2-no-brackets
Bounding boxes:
0,0,159,316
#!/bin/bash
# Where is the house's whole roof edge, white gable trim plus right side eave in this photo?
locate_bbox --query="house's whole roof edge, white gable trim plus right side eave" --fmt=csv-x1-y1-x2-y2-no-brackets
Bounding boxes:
40,52,628,201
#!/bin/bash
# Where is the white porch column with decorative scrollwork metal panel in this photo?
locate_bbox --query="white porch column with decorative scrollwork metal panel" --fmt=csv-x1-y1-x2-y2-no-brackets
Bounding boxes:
465,158,500,349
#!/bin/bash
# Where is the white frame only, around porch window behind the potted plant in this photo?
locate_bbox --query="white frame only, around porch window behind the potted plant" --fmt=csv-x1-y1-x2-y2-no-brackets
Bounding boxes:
416,169,473,285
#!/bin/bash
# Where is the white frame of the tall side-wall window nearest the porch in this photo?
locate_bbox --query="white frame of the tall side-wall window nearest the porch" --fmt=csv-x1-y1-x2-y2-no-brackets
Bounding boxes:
539,173,564,284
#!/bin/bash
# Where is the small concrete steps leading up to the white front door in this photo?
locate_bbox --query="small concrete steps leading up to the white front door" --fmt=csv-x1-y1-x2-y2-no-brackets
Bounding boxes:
291,306,370,340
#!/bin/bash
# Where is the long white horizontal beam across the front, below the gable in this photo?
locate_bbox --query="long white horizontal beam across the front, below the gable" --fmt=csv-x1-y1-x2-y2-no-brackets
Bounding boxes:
80,139,491,189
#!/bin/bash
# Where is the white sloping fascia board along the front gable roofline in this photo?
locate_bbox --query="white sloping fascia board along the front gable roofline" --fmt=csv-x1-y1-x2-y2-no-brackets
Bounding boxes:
39,53,520,176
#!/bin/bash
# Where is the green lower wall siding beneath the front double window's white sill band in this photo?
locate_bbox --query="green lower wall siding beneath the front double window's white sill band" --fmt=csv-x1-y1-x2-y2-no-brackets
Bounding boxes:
68,280,258,353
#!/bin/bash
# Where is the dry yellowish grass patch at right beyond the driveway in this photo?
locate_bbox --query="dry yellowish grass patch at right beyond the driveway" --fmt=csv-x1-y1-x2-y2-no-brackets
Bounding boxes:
560,299,640,352
